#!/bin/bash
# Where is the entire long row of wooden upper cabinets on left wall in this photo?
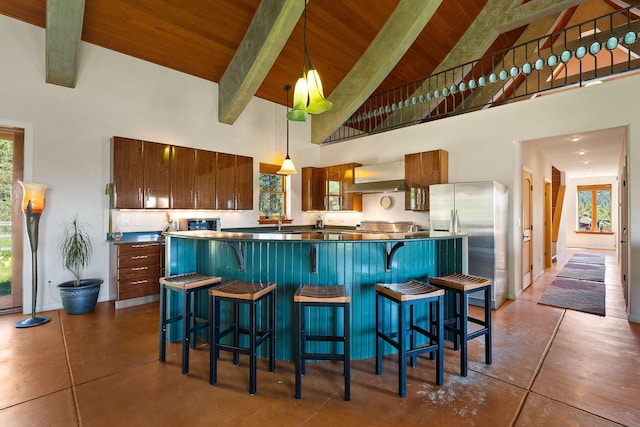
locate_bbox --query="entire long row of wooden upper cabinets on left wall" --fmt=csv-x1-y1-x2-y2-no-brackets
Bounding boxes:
111,137,253,210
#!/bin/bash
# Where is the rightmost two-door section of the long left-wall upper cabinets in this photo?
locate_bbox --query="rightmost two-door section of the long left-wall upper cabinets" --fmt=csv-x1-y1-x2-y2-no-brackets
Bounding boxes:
216,153,253,210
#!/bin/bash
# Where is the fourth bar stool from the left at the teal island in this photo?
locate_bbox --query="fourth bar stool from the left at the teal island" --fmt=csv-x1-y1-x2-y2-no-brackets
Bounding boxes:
375,280,444,397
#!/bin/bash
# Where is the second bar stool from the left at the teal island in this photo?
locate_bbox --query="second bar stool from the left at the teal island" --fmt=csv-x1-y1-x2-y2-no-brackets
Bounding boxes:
209,280,276,394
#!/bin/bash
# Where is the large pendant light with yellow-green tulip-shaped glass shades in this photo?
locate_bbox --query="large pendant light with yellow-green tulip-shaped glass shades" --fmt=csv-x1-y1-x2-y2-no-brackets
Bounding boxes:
287,0,333,122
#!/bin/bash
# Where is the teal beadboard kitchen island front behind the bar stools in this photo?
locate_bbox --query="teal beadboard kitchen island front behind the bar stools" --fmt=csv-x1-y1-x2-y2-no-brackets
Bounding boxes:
164,230,467,360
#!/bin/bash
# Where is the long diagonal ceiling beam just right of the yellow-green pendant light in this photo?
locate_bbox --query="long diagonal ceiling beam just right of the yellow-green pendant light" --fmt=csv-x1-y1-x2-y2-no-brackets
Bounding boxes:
311,0,442,144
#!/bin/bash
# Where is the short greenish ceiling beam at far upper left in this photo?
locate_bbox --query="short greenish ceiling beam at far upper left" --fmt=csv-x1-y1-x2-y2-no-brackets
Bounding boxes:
45,0,85,88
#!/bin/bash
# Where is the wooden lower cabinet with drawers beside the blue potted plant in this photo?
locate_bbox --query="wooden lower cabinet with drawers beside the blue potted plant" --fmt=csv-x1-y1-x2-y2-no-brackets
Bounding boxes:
112,242,164,308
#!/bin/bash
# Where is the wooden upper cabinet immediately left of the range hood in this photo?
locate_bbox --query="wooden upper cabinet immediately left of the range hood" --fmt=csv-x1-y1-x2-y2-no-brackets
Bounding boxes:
302,163,362,211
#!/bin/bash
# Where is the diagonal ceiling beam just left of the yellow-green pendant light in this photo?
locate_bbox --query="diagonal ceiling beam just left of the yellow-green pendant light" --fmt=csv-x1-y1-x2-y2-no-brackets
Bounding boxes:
218,0,305,124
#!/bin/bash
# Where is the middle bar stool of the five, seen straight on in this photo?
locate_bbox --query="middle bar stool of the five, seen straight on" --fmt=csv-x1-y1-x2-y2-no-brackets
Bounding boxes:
293,285,351,401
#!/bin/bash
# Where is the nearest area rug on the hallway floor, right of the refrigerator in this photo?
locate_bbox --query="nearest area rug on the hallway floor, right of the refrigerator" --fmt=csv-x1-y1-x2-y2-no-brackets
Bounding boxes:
539,278,605,316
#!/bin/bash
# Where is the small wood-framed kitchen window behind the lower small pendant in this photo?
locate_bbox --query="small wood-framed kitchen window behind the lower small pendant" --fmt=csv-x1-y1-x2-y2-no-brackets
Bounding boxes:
258,163,287,222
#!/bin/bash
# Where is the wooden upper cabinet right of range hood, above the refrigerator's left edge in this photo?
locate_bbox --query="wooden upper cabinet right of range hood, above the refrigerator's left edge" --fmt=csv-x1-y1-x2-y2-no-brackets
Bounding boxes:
404,150,449,211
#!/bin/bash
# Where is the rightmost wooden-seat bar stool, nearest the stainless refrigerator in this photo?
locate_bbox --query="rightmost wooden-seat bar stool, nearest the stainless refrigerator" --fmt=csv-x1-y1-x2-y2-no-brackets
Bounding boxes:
429,273,492,377
